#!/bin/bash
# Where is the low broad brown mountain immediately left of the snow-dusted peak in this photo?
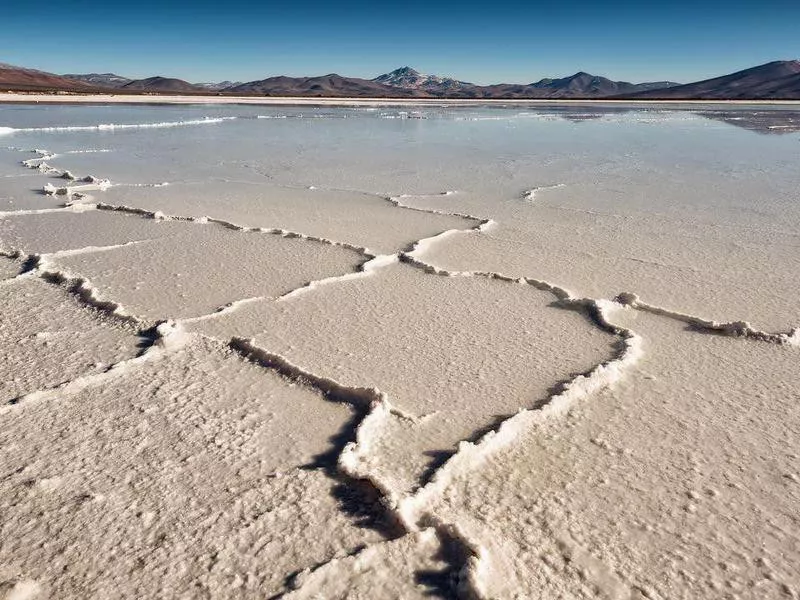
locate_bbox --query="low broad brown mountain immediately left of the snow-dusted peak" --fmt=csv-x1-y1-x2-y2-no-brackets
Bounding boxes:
225,73,429,98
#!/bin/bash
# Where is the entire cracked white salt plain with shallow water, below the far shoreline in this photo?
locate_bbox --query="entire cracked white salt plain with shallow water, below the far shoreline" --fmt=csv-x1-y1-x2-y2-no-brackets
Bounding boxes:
0,104,800,600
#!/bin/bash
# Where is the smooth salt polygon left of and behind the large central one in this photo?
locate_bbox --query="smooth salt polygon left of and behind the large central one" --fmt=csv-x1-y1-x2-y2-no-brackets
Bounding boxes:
48,220,363,320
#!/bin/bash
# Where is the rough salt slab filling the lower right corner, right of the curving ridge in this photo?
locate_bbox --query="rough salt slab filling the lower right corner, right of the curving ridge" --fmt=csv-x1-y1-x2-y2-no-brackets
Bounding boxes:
422,309,800,598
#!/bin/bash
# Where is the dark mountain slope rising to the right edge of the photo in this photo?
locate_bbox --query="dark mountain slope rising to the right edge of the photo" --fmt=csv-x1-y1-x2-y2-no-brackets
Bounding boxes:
623,60,800,100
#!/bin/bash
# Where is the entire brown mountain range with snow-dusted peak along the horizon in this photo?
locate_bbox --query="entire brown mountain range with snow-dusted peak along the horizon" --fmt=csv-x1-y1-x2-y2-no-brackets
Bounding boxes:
0,60,800,100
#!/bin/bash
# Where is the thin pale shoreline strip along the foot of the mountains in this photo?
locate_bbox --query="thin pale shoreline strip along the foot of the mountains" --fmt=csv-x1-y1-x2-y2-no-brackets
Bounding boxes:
0,92,800,107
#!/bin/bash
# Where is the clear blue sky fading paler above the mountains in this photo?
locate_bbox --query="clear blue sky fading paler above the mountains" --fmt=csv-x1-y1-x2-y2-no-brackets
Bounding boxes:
0,0,800,83
